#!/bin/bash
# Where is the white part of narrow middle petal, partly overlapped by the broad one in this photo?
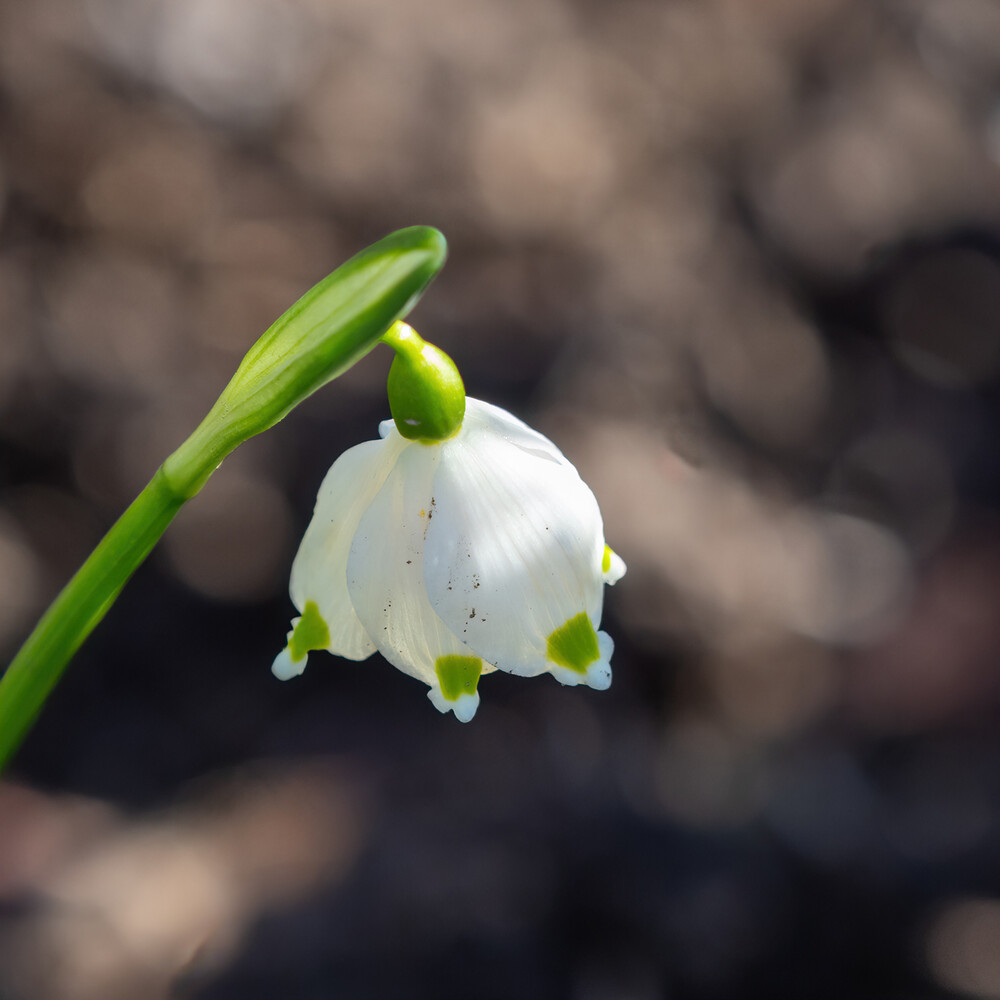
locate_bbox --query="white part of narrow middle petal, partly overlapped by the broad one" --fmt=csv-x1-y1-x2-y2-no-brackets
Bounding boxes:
347,444,484,687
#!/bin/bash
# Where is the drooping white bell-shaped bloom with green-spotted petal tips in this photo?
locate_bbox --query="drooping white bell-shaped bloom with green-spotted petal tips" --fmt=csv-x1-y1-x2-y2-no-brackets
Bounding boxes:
272,399,625,722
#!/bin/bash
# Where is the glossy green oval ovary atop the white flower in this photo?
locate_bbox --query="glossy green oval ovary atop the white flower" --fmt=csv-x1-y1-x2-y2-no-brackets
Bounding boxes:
382,323,465,444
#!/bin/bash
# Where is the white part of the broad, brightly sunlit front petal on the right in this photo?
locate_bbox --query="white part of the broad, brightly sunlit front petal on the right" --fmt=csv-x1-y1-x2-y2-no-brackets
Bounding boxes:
424,400,604,676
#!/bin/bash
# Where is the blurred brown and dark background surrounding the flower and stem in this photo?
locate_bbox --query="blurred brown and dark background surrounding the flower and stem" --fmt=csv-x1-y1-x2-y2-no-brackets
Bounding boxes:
0,0,1000,1000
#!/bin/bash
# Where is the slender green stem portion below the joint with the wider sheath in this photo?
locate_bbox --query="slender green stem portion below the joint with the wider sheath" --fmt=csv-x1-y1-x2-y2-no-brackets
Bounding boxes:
0,469,185,768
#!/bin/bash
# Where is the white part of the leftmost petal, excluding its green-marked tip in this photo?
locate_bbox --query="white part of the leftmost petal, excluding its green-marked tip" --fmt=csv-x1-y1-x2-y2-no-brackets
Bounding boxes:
290,435,402,660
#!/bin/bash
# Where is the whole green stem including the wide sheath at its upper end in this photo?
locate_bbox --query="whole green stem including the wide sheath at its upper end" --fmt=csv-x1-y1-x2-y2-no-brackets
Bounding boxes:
0,226,446,769
